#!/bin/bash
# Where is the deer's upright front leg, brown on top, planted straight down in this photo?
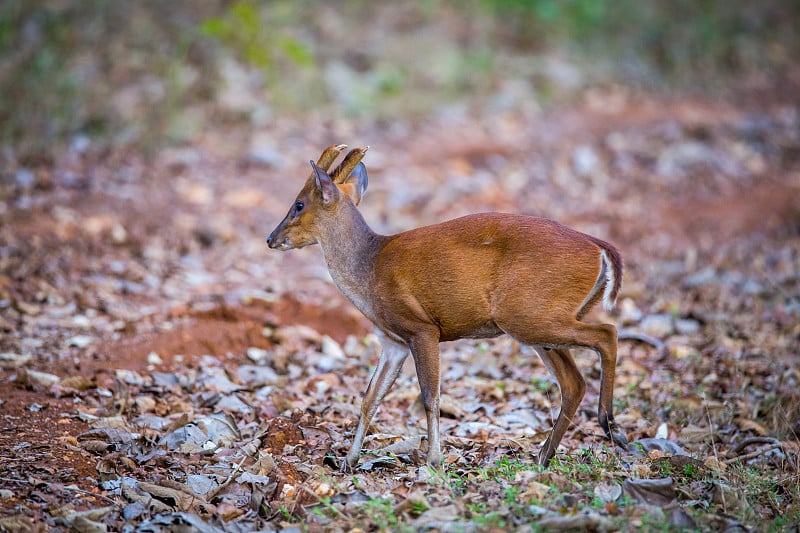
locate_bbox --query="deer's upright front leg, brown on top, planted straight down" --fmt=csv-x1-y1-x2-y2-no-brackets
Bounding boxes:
411,332,442,467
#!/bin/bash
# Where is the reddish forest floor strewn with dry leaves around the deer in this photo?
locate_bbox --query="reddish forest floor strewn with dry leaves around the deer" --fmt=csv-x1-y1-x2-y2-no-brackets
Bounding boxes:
0,81,800,531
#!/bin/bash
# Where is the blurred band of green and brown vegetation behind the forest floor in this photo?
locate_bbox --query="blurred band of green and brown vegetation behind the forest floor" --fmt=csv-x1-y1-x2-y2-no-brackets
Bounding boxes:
0,0,800,154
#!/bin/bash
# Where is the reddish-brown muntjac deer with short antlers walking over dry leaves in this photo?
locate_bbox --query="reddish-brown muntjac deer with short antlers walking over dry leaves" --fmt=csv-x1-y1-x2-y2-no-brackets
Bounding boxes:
267,145,627,470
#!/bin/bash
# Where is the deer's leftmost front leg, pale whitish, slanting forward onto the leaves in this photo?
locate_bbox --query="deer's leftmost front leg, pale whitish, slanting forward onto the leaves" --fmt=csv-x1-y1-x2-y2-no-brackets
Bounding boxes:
342,331,408,472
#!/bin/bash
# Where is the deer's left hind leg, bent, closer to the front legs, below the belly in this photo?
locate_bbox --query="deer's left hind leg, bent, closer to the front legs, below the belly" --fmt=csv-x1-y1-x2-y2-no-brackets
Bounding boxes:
536,348,586,466
